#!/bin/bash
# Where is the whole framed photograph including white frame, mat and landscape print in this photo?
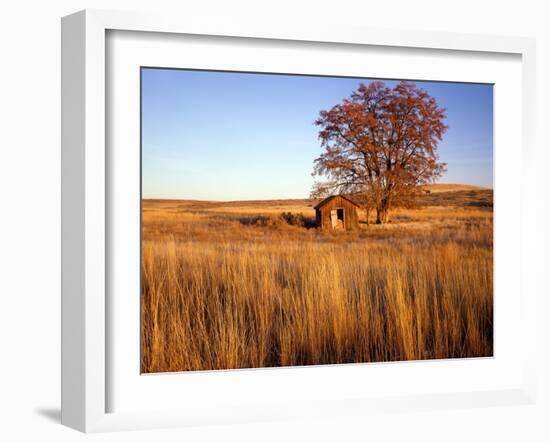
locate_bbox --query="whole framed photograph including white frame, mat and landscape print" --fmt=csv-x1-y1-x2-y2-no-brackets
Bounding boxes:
62,11,536,432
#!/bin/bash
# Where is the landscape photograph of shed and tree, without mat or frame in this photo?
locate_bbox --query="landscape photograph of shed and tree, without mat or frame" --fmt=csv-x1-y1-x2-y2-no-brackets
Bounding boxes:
140,67,494,374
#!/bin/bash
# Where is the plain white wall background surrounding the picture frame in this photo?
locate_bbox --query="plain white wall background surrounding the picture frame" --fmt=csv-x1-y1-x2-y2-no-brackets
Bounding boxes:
0,0,550,441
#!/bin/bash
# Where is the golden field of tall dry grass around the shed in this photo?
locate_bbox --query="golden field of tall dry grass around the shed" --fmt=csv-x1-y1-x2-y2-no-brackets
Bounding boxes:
141,185,493,373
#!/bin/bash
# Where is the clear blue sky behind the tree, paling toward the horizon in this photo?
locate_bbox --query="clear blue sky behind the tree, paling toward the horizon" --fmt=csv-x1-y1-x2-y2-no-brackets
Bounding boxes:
142,68,493,200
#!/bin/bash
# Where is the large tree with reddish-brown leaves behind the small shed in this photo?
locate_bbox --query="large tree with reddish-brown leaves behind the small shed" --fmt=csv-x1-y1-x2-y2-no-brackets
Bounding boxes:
312,81,447,223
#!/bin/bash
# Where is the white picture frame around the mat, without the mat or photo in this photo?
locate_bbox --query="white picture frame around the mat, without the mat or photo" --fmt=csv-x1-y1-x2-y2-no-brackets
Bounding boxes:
62,10,536,432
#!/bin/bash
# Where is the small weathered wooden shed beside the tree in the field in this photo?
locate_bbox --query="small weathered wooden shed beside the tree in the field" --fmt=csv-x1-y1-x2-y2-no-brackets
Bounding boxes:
315,195,359,230
